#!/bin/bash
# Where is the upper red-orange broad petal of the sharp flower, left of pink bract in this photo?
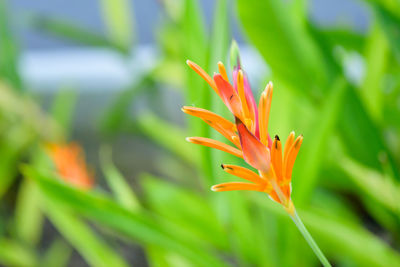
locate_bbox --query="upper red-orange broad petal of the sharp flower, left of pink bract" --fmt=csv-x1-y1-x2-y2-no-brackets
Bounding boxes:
214,74,242,118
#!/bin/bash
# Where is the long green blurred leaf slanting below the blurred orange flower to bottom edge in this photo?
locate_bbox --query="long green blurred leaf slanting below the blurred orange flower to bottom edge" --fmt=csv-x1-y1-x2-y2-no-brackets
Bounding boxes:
23,166,226,266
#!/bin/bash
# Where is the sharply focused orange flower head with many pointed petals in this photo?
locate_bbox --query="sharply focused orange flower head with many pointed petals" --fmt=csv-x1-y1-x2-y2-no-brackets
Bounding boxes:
182,60,303,212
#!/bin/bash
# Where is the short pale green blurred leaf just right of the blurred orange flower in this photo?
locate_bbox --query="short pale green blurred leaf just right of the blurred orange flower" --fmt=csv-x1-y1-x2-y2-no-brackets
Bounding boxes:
100,146,140,210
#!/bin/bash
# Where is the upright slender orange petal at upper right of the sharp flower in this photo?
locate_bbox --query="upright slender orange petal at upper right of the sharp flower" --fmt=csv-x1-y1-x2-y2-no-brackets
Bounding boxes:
258,82,273,146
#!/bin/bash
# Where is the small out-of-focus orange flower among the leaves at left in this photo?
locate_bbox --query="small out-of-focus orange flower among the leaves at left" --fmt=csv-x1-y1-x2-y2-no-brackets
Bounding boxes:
47,143,94,190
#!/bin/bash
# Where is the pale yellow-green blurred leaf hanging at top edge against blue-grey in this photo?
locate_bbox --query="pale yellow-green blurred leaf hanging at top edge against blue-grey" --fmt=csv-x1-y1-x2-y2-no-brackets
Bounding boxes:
100,0,134,51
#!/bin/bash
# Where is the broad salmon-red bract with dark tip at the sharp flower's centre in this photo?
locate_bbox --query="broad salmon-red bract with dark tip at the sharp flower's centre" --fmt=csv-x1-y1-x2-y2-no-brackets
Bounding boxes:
236,118,271,173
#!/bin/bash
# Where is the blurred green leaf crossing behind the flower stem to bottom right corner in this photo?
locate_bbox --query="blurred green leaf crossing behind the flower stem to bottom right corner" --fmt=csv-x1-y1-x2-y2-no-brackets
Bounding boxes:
254,197,400,267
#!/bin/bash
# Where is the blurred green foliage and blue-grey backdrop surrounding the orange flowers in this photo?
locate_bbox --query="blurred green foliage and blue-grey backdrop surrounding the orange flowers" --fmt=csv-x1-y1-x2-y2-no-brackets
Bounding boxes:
0,0,400,267
